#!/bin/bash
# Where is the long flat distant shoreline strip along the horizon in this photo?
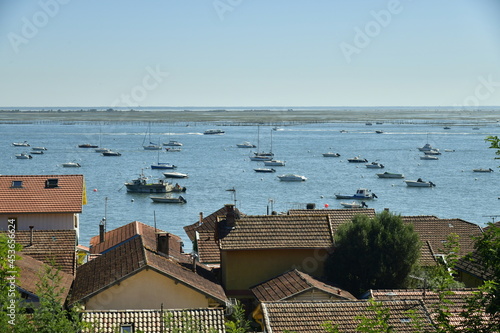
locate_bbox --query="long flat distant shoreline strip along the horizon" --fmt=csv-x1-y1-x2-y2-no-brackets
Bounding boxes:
0,108,500,124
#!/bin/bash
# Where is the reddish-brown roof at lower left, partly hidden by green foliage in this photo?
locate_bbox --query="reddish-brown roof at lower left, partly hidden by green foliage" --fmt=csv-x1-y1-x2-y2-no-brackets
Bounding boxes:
16,253,73,303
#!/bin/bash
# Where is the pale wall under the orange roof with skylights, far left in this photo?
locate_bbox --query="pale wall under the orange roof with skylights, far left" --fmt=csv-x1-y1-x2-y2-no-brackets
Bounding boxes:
0,213,80,230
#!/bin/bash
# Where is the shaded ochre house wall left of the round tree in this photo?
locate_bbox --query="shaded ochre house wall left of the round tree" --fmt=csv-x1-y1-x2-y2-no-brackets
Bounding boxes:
221,249,327,297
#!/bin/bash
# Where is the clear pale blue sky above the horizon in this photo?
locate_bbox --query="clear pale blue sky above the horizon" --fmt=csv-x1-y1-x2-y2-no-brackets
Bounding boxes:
0,0,500,108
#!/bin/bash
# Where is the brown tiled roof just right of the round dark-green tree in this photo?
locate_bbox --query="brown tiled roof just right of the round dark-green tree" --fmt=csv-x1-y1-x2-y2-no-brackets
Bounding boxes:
401,216,482,255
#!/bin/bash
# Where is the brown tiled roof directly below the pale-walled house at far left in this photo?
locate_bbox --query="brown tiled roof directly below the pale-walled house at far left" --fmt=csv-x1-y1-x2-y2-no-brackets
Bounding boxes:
0,230,76,275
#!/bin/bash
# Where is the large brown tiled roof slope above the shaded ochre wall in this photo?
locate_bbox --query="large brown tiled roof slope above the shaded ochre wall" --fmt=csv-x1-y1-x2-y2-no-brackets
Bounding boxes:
220,215,333,250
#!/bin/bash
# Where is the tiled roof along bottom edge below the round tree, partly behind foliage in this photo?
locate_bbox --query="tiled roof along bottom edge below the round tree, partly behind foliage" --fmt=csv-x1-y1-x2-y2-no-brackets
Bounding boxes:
262,301,431,333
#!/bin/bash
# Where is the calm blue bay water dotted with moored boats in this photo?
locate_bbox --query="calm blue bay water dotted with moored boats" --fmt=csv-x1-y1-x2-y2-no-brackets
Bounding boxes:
0,122,500,251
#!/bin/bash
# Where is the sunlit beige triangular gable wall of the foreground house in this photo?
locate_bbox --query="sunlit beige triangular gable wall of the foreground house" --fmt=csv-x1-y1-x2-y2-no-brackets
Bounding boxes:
85,269,213,310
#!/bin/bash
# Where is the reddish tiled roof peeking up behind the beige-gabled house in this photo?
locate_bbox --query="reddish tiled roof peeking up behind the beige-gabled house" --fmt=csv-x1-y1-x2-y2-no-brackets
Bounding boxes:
90,221,185,260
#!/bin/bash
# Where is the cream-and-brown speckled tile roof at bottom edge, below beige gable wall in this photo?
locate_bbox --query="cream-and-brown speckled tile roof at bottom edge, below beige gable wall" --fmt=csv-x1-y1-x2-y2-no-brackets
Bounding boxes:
83,309,225,333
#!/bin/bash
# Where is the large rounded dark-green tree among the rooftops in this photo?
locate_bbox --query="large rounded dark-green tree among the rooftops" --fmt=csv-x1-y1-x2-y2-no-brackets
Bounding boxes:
325,211,421,295
